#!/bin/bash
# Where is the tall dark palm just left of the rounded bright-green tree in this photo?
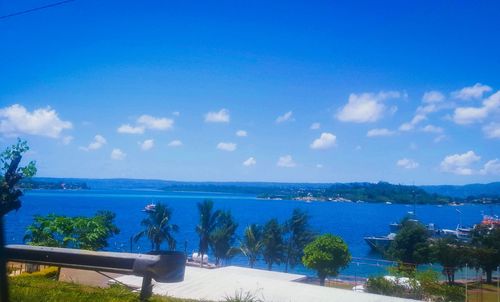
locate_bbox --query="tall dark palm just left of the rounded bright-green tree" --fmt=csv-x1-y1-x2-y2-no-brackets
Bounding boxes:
285,209,314,272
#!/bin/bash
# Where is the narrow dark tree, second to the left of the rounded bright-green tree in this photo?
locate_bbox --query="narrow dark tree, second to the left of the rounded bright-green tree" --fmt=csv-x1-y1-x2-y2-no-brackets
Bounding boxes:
262,218,285,270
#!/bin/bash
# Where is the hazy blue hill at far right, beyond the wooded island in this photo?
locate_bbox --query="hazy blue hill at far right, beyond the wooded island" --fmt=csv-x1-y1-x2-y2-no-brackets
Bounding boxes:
420,182,500,198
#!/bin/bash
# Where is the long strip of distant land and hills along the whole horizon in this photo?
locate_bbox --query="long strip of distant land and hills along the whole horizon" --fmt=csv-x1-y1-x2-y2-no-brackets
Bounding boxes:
21,177,500,203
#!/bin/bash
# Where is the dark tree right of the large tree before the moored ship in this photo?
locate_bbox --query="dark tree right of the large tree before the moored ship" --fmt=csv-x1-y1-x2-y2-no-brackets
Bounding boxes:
430,238,468,285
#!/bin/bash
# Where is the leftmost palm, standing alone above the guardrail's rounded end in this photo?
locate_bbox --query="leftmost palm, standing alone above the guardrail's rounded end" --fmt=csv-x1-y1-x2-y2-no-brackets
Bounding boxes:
134,203,179,251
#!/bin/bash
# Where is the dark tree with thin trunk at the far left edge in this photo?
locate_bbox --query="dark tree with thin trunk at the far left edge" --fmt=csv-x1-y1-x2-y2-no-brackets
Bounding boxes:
0,139,36,301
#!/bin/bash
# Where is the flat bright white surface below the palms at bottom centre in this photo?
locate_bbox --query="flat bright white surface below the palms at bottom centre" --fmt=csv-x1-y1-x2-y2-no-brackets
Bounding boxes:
117,266,416,302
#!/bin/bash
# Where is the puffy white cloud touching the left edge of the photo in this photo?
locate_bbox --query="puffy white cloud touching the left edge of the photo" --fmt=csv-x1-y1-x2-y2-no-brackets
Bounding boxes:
0,104,73,138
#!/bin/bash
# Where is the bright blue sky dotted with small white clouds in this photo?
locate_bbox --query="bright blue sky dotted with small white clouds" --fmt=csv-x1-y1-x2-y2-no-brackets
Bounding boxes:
0,0,500,184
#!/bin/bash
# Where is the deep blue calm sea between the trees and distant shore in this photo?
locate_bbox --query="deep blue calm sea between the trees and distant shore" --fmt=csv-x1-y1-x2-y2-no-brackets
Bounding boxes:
2,190,500,276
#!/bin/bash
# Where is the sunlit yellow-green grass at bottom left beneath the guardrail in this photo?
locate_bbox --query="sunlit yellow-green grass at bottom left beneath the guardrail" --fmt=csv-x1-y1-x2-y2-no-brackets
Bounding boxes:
9,274,199,302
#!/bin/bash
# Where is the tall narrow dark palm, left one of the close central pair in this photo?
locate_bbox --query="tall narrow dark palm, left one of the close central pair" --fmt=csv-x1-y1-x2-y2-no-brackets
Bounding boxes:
196,199,220,266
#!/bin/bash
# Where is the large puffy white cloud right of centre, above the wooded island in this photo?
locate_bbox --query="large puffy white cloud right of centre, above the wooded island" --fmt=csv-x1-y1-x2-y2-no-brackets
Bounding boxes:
337,91,401,123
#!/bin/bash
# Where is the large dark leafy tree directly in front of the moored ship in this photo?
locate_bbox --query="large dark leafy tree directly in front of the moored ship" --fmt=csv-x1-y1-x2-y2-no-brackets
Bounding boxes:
387,219,430,266
